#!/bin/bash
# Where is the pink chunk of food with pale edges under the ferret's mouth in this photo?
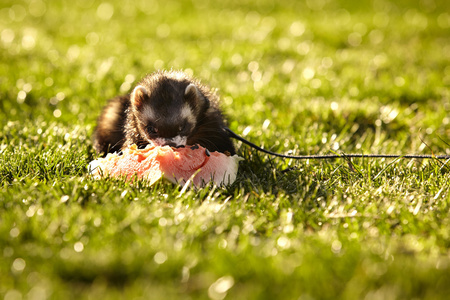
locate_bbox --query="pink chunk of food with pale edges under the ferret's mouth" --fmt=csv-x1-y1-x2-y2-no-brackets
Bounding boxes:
89,145,242,187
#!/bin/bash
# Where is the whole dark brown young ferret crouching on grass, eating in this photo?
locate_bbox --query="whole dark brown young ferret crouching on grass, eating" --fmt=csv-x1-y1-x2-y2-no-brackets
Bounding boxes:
94,71,236,155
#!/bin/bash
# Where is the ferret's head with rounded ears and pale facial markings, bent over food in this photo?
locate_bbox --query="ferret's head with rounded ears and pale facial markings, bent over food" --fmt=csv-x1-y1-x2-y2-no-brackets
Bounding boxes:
130,73,209,147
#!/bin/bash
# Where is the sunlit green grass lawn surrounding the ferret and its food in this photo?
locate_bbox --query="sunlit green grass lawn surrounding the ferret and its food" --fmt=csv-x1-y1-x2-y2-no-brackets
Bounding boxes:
0,0,450,300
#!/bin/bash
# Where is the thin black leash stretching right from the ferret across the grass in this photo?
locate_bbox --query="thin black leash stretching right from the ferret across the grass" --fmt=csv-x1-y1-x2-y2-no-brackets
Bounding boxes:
225,127,450,160
